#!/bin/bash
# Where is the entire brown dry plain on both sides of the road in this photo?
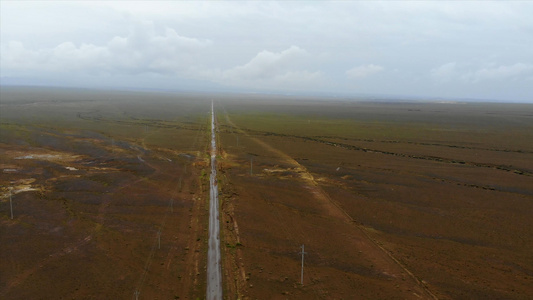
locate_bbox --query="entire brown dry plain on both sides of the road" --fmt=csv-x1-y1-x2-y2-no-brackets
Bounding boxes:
0,88,533,299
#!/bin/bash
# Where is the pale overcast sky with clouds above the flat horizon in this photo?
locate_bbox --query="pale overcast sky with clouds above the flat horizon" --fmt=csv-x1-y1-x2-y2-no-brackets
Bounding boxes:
0,1,533,102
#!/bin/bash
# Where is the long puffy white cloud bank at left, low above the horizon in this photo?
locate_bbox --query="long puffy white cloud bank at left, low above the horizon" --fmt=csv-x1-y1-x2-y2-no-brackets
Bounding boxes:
1,23,212,74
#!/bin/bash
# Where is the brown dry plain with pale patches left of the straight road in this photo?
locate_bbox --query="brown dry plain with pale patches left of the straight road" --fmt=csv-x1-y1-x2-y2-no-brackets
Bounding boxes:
0,88,214,299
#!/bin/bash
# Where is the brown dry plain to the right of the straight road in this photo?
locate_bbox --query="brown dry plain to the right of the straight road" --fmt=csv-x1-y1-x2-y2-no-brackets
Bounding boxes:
214,99,533,299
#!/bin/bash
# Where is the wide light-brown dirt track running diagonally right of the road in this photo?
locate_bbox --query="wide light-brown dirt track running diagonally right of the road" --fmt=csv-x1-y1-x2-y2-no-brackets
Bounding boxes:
220,114,438,299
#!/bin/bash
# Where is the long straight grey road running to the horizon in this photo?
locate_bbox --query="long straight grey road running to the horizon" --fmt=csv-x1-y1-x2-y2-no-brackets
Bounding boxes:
206,102,222,300
